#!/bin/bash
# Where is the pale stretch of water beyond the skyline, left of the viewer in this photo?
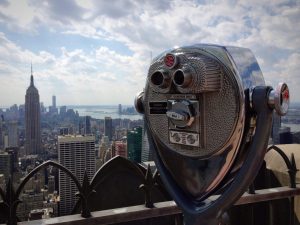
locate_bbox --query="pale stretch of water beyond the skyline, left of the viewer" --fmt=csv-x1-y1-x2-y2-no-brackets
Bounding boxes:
67,105,143,120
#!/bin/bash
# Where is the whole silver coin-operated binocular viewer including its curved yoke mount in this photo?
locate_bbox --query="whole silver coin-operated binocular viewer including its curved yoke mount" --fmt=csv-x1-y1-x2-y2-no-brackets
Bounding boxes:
135,45,289,225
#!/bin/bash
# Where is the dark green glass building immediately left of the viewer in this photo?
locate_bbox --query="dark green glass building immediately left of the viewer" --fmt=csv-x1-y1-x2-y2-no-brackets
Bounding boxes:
127,127,143,163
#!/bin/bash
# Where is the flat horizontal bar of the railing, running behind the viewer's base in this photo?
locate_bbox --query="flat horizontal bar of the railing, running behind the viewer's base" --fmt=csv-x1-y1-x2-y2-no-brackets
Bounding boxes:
13,185,300,225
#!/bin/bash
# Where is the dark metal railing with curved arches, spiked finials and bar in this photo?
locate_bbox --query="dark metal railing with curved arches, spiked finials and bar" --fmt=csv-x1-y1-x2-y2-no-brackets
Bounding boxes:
0,145,300,225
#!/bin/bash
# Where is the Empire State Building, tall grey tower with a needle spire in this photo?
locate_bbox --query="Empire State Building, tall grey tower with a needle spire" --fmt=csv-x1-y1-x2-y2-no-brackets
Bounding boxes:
25,68,41,155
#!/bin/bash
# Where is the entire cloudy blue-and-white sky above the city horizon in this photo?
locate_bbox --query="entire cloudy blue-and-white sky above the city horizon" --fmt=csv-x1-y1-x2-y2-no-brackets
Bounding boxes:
0,0,300,106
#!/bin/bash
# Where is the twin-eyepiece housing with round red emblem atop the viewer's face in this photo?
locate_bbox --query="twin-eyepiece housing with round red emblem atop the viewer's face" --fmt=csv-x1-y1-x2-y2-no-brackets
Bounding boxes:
149,53,222,93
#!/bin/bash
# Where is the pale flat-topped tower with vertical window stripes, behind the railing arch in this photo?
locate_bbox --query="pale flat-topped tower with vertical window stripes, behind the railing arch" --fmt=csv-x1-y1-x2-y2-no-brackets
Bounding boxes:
58,135,96,216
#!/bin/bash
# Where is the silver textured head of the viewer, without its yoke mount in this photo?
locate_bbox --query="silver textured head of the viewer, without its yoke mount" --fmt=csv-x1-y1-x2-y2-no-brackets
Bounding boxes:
144,45,265,199
